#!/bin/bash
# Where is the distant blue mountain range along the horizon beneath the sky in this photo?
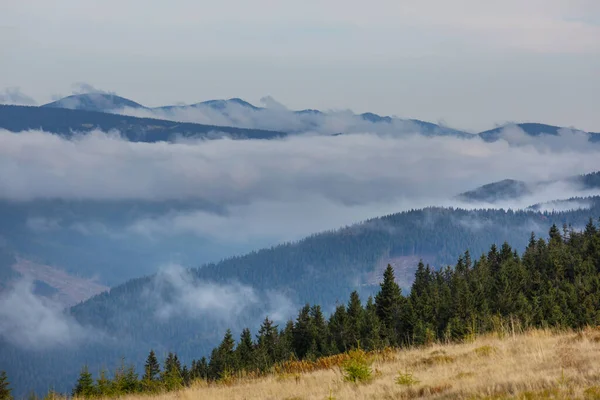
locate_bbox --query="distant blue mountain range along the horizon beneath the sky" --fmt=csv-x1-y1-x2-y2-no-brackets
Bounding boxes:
0,93,588,142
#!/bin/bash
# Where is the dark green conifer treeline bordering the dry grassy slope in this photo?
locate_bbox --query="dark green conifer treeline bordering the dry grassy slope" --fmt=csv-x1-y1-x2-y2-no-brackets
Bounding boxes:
68,220,600,397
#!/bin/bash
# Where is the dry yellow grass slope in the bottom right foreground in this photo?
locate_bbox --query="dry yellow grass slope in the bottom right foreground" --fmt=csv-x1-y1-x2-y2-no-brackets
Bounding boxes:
118,329,600,400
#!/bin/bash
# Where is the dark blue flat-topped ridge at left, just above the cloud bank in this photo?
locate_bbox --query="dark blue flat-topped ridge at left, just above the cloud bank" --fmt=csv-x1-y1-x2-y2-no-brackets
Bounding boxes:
0,105,286,142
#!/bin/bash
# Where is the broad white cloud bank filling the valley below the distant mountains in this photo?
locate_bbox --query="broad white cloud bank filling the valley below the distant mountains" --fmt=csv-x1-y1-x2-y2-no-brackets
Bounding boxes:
0,128,600,245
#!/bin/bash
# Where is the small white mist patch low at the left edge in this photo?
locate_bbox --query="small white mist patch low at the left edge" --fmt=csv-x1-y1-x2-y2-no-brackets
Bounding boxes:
0,278,94,350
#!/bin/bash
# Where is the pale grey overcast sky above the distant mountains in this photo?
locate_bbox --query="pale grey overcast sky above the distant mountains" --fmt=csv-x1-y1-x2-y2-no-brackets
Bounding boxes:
0,0,600,131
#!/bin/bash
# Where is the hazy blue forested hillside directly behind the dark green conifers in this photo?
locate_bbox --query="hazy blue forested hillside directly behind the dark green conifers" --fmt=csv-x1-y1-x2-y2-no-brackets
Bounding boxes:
1,199,600,396
